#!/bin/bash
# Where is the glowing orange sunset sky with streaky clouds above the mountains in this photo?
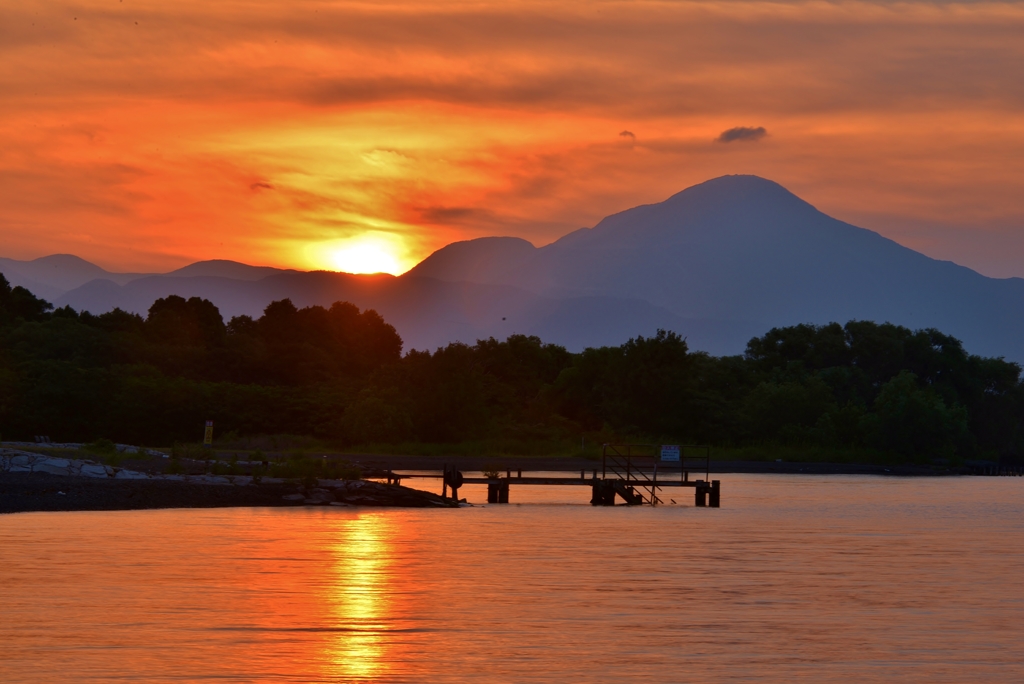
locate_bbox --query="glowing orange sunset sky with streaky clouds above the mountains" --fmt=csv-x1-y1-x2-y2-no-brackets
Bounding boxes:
0,0,1024,276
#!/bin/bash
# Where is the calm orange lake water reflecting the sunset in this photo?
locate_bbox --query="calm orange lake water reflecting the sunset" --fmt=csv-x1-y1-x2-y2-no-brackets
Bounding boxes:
0,475,1024,684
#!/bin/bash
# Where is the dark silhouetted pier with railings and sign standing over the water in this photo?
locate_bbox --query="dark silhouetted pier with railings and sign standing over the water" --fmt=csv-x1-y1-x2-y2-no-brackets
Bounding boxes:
387,444,722,508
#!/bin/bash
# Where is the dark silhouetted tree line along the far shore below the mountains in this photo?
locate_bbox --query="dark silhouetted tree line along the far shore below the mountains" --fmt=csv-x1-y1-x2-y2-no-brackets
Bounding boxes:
0,275,1024,460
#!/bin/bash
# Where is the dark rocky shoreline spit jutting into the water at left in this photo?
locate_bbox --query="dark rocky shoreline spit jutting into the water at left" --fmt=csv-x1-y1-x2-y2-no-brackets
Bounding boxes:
0,448,458,513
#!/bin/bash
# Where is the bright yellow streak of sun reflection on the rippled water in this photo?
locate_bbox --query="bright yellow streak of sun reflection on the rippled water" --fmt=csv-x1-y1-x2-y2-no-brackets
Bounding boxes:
326,514,394,680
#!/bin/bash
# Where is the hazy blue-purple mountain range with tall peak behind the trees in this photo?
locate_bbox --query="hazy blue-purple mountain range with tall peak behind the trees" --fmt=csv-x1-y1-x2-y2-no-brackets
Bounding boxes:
0,176,1024,361
